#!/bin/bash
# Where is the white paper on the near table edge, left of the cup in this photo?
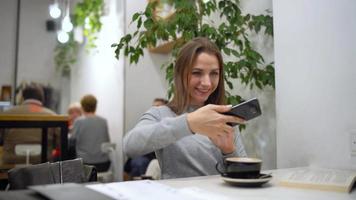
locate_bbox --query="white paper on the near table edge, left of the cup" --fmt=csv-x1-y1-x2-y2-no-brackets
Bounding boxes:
86,180,229,200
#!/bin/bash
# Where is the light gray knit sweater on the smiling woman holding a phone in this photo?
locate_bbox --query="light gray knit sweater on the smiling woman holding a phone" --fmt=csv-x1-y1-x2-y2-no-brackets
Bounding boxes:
123,106,246,179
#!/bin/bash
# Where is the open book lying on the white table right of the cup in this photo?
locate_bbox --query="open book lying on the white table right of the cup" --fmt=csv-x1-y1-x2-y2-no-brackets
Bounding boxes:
279,167,356,192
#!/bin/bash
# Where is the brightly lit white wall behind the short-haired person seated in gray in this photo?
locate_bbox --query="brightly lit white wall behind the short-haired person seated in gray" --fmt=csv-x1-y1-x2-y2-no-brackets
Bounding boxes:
70,0,124,180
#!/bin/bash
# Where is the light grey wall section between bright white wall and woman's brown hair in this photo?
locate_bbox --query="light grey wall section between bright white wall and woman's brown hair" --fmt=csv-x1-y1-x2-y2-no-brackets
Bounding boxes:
124,1,169,132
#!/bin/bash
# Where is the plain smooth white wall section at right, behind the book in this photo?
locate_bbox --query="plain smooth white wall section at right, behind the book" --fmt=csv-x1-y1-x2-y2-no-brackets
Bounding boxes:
273,0,356,169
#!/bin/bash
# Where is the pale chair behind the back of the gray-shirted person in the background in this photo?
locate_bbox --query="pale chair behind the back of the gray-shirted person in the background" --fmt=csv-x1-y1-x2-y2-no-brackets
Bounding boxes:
98,142,119,183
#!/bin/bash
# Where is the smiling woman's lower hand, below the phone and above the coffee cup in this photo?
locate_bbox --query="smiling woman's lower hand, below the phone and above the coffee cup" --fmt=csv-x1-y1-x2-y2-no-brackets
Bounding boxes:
210,132,236,154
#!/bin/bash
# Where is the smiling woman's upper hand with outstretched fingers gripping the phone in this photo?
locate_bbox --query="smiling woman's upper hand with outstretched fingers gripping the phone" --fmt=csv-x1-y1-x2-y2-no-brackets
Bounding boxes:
187,104,244,138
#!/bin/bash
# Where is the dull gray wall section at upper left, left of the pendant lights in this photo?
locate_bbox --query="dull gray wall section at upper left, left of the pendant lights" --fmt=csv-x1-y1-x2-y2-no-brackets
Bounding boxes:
18,0,61,88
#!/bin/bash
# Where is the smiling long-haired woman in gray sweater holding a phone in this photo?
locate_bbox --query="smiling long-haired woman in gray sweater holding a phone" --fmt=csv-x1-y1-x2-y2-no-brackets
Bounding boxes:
124,38,246,179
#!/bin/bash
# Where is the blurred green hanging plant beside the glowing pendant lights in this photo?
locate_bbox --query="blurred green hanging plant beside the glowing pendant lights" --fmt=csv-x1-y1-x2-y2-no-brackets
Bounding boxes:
54,0,104,76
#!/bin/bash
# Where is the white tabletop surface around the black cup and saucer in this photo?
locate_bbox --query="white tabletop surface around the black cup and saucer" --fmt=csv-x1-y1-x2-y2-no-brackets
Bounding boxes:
158,169,356,200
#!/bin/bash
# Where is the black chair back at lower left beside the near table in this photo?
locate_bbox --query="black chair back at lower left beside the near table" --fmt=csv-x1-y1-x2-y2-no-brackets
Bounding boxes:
8,158,97,190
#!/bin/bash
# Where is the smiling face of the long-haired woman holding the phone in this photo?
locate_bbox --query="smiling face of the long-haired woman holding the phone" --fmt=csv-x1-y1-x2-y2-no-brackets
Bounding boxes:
188,52,220,106
